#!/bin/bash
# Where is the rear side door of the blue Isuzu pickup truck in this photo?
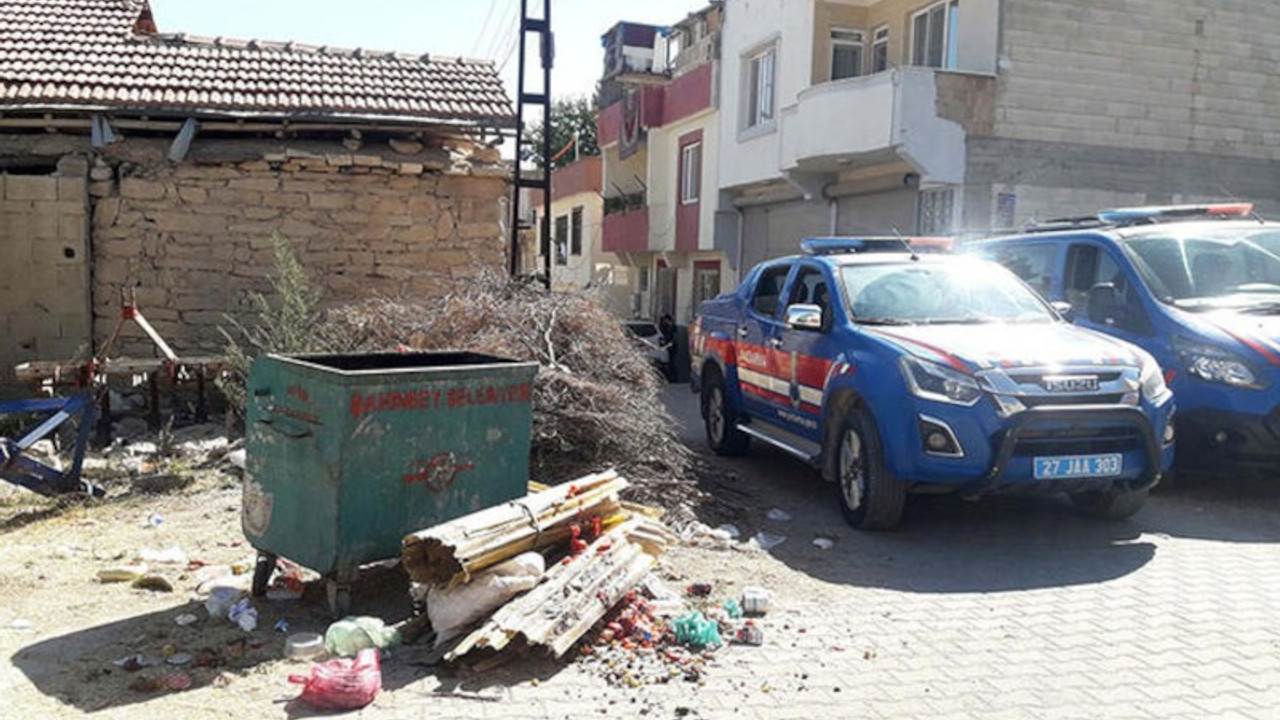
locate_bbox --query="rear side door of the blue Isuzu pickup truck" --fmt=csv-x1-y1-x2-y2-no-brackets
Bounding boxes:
733,263,792,421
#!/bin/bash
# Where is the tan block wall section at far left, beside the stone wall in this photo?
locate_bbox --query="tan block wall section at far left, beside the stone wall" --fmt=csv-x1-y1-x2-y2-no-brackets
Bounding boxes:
0,158,90,387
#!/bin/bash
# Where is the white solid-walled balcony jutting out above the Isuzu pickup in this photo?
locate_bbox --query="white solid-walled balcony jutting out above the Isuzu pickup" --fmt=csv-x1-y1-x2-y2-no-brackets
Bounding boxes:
781,68,996,183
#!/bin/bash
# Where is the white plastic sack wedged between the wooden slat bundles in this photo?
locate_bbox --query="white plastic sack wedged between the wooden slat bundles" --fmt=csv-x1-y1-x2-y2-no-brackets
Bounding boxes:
426,552,547,646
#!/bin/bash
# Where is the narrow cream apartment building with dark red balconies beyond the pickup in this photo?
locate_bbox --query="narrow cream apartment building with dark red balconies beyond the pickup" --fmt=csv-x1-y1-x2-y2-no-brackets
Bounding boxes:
598,1,732,324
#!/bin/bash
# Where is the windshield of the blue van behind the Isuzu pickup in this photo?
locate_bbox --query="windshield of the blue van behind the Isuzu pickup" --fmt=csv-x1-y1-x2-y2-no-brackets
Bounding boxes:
1125,228,1280,310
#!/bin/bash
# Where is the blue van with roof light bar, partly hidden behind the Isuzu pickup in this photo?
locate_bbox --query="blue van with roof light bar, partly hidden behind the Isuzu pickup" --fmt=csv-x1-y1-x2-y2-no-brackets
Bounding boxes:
966,202,1280,474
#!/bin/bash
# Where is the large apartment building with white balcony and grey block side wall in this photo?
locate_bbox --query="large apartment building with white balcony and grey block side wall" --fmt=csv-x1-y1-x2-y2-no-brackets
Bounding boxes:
713,0,1280,270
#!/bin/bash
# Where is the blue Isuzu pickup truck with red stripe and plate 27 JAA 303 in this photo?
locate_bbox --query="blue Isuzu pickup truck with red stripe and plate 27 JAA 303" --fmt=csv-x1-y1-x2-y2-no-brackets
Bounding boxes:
690,238,1174,529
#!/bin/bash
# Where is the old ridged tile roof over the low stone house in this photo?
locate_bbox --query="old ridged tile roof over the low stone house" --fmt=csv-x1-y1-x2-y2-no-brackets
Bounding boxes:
0,0,513,126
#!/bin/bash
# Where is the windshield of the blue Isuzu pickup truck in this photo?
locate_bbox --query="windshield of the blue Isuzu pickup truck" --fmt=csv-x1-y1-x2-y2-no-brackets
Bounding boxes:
841,259,1057,325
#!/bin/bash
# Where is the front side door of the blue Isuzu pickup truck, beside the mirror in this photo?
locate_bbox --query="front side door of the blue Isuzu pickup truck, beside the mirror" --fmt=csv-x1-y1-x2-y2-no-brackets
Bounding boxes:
774,264,842,442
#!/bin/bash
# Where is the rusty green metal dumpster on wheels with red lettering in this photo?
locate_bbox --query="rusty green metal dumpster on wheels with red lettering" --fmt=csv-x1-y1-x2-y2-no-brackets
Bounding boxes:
241,352,538,614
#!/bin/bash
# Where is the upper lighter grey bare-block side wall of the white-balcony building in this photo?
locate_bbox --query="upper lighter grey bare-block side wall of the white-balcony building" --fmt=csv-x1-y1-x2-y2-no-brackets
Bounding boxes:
995,0,1280,160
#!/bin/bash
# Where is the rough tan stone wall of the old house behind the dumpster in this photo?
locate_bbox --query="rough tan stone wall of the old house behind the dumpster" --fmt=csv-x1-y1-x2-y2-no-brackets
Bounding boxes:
90,141,508,355
